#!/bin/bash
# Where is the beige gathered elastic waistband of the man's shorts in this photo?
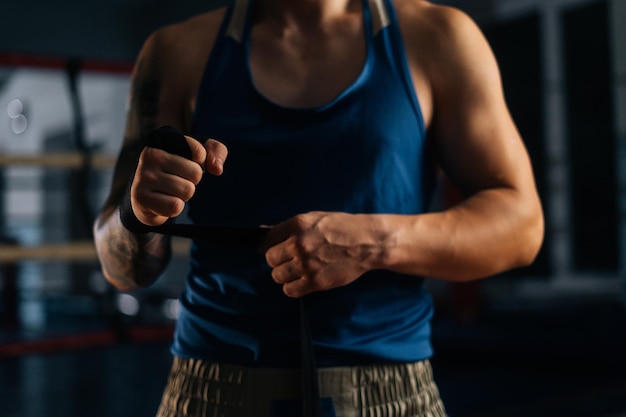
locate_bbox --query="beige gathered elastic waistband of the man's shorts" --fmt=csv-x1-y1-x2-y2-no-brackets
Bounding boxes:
158,356,445,417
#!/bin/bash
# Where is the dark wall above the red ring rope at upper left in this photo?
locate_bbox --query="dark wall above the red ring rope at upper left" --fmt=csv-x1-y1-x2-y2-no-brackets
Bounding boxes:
0,0,227,62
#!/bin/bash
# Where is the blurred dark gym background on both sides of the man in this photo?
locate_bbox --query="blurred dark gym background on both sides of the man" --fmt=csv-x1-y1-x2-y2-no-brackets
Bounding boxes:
0,0,626,417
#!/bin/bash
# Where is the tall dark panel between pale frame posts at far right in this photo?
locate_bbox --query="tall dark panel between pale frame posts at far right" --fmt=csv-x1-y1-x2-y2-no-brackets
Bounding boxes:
563,2,619,272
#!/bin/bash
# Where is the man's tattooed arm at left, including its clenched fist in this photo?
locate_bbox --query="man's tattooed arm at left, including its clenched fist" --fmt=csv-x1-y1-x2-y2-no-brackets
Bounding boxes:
94,17,228,290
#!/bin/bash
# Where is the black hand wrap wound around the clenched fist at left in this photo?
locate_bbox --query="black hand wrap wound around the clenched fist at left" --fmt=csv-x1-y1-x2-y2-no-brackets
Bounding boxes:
119,126,192,234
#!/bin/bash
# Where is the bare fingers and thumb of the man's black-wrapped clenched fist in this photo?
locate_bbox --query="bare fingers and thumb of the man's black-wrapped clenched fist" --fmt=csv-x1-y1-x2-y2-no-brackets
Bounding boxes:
131,136,228,226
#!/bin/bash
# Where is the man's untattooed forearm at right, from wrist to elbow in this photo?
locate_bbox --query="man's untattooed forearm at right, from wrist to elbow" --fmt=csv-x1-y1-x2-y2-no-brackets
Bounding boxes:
372,189,543,281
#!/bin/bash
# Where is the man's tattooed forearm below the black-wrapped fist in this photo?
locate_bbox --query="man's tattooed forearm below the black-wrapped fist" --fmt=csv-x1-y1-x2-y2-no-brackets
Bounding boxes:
94,208,171,291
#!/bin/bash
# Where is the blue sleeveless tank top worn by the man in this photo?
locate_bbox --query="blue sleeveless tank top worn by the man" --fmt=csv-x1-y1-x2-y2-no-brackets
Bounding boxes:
172,0,434,367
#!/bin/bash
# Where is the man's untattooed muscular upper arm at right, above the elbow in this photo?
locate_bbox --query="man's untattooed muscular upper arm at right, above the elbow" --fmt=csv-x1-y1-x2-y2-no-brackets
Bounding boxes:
430,8,534,196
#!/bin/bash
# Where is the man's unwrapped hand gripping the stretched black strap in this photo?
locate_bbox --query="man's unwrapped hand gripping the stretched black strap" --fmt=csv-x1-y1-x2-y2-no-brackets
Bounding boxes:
264,212,384,297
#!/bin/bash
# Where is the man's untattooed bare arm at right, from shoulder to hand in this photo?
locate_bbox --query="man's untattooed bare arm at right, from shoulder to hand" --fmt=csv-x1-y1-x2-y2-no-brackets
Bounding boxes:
265,0,543,297
